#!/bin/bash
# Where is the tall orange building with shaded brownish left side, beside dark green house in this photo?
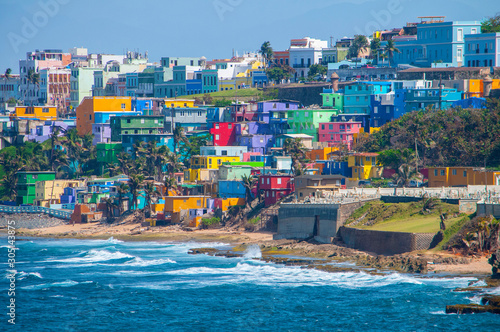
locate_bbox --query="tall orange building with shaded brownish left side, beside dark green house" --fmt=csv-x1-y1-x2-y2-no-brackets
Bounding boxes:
76,97,135,136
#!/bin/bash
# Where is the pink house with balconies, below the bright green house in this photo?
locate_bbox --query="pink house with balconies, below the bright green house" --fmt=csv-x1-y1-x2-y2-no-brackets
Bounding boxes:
318,122,362,150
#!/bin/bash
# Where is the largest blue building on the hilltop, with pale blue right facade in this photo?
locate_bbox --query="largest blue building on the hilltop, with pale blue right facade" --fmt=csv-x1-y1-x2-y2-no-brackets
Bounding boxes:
392,17,481,67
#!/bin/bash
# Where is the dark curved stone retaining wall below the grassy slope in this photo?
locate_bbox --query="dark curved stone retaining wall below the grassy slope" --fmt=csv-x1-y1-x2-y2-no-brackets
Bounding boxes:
339,226,435,255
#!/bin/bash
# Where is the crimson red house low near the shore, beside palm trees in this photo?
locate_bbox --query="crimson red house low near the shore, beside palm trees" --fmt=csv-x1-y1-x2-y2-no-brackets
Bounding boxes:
259,174,295,206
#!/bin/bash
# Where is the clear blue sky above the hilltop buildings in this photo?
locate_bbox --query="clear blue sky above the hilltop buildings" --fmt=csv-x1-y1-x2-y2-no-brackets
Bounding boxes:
0,0,500,74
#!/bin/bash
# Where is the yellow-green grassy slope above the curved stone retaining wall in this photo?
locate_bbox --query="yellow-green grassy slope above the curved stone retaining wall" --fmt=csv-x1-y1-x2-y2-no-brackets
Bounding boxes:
347,201,463,233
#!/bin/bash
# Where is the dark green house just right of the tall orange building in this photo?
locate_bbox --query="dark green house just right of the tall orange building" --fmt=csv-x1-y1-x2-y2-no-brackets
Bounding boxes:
110,115,165,142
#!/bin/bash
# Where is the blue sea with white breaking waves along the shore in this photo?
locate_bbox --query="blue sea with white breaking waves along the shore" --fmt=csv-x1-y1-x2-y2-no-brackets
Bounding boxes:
0,238,500,331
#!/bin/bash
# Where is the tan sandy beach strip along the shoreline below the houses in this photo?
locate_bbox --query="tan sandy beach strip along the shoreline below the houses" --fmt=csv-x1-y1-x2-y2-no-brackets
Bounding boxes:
9,219,491,276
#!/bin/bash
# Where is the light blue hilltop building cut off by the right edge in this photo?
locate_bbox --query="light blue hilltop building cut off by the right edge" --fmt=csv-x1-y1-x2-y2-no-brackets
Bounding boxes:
464,32,500,67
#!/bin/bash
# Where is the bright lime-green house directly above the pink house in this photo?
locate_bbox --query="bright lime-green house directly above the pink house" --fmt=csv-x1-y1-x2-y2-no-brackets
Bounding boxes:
287,108,339,142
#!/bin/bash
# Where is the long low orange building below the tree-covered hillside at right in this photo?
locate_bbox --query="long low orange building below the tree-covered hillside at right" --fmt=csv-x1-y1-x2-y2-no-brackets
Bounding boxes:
428,167,500,187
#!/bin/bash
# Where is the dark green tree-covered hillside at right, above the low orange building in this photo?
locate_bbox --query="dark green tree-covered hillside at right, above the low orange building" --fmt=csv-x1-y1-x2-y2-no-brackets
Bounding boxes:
356,100,500,168
